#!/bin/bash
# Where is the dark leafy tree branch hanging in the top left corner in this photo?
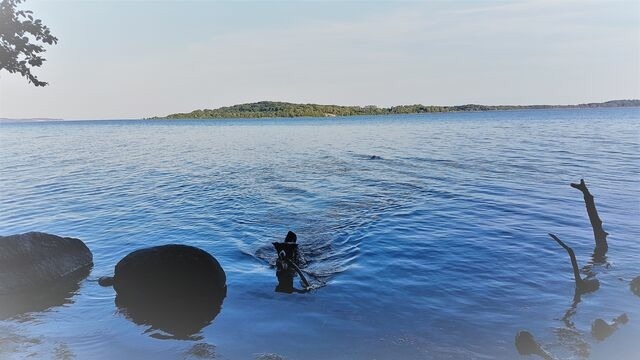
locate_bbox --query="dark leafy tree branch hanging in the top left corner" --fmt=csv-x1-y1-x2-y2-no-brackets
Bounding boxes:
0,0,58,86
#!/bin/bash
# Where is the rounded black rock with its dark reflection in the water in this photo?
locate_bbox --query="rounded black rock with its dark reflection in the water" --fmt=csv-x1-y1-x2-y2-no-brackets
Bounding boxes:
108,245,227,338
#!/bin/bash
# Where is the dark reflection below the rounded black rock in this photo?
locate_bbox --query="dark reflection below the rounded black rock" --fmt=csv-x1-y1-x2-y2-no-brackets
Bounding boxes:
116,286,226,340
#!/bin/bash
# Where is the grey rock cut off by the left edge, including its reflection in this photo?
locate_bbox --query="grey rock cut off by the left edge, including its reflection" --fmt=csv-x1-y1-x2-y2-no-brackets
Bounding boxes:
0,232,93,319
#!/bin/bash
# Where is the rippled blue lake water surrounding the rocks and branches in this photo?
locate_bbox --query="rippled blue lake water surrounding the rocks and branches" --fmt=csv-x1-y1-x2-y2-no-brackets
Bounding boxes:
0,108,640,359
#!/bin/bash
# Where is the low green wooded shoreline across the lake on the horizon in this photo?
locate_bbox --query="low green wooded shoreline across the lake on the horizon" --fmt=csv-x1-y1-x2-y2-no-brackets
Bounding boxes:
151,100,640,119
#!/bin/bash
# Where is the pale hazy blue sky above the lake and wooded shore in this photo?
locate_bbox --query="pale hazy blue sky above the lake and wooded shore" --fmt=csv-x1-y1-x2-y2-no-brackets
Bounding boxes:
0,0,640,119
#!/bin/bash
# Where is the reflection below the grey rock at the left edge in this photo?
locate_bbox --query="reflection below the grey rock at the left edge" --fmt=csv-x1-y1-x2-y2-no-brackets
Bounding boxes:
0,267,91,320
